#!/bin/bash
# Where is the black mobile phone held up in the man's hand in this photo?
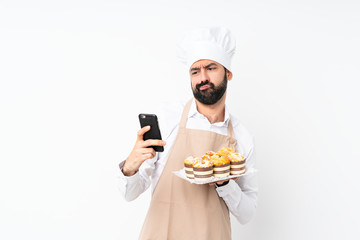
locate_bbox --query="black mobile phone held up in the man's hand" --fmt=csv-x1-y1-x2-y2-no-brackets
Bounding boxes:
139,113,164,152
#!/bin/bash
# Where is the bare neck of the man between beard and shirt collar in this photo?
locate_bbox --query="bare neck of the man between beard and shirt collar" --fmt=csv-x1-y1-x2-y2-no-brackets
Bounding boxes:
195,93,226,124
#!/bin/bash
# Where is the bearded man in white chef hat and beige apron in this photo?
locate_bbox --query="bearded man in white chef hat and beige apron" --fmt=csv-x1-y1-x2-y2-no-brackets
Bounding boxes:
119,27,257,240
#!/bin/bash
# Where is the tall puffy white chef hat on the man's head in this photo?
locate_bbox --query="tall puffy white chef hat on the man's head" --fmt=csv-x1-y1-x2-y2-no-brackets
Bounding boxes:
177,27,236,71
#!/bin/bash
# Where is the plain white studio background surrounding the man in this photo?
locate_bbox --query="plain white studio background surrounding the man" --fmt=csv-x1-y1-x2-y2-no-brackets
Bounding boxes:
0,0,360,240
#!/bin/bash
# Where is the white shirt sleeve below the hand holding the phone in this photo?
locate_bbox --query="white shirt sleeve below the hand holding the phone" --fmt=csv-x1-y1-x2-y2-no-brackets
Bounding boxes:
118,153,159,201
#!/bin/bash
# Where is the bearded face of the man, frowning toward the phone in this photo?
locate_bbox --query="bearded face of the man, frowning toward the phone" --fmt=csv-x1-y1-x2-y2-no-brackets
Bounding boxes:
190,59,232,105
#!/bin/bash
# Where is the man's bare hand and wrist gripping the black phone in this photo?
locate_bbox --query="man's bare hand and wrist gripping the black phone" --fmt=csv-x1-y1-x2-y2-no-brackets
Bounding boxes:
122,126,166,176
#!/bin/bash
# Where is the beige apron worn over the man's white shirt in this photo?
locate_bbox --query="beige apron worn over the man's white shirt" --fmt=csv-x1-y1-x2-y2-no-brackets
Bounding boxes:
139,98,236,240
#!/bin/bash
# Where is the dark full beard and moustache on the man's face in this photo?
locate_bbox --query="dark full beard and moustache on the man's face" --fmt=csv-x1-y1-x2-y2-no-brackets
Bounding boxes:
192,72,227,105
